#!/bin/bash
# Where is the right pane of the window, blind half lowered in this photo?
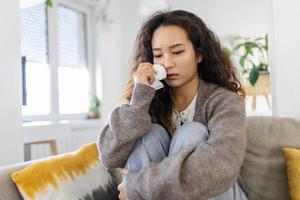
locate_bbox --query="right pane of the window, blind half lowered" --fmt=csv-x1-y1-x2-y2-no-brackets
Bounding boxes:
58,6,89,114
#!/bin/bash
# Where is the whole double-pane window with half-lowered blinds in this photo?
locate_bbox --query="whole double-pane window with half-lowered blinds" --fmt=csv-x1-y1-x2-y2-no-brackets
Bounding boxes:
21,0,93,120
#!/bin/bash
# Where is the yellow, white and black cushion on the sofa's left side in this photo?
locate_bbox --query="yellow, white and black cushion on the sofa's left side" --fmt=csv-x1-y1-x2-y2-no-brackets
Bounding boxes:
11,143,118,200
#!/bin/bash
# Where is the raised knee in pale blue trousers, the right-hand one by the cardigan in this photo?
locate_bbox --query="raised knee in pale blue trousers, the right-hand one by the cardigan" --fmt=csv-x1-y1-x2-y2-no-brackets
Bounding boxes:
169,122,209,155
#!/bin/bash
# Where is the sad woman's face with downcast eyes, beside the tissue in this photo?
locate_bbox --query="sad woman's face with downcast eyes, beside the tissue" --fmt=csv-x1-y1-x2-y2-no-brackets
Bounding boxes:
151,25,202,88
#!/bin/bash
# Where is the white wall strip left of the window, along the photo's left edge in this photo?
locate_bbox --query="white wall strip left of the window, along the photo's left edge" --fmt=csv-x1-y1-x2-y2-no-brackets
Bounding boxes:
0,0,23,166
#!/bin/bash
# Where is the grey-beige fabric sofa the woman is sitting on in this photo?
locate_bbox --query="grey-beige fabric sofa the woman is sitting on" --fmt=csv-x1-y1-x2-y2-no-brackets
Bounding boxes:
0,117,300,200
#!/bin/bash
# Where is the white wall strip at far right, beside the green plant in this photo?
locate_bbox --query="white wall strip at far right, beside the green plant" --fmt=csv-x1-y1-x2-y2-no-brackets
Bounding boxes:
270,0,300,117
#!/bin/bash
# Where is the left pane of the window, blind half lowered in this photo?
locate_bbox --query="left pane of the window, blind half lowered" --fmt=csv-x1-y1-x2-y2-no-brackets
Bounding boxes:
20,4,50,115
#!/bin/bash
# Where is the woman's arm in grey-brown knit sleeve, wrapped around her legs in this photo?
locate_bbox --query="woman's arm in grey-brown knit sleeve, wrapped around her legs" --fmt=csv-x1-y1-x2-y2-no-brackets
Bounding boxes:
125,90,246,200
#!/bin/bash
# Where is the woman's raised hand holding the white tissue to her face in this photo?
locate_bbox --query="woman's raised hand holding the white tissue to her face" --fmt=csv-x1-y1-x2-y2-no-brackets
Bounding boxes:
133,62,155,86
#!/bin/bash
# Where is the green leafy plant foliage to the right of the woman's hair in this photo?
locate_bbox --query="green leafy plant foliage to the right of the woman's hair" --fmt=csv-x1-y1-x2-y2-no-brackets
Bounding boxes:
223,35,269,86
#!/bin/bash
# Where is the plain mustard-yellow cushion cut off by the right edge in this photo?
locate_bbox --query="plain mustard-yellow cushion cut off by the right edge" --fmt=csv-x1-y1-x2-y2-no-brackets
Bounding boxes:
282,147,300,200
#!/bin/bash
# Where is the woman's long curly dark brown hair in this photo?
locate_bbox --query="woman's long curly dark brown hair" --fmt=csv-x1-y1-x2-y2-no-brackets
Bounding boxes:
122,10,245,133
